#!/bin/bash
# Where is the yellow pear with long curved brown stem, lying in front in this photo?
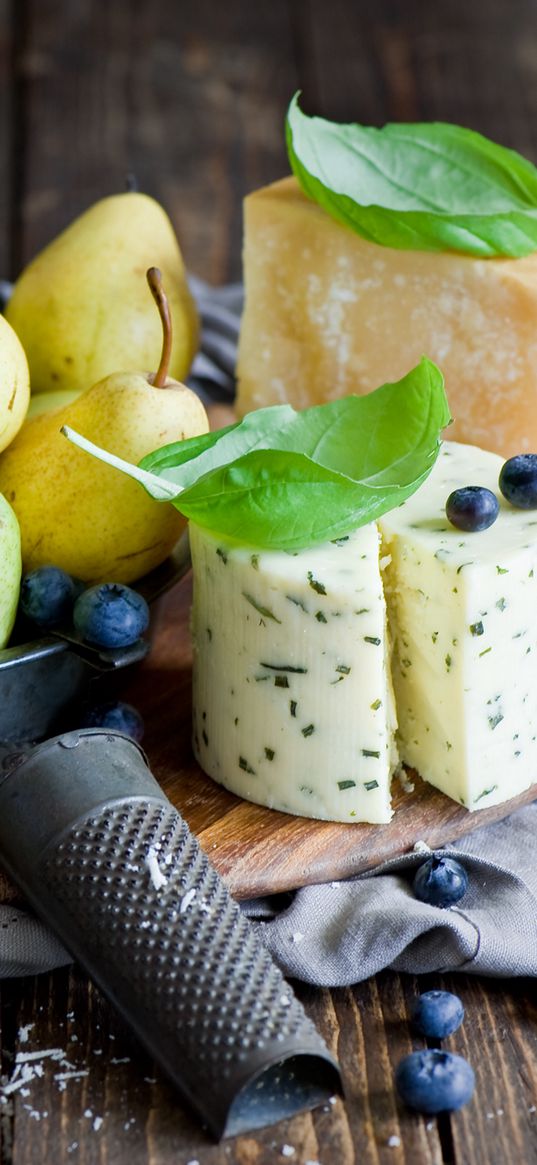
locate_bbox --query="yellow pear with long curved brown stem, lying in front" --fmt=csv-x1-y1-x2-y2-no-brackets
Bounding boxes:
0,271,209,583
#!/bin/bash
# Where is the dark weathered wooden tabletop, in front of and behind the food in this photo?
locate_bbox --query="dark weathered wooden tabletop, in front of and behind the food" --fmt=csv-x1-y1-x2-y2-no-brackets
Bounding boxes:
0,0,537,1165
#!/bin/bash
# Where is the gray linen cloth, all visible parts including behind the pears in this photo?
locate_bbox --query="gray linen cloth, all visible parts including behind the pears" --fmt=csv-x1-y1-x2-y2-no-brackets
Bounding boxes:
0,280,537,987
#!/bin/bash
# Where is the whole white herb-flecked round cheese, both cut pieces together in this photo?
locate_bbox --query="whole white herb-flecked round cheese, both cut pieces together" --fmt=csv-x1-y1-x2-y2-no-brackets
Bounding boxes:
191,442,537,822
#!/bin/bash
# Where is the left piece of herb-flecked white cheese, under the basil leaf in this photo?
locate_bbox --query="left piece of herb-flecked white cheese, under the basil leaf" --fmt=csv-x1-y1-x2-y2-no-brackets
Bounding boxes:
190,525,397,822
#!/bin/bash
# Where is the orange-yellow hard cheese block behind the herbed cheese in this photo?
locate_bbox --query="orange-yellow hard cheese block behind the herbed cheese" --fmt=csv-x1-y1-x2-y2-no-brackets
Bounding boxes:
238,178,537,457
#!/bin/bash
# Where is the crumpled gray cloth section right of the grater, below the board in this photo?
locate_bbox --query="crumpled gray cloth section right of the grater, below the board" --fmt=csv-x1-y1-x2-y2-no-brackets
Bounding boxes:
245,803,537,987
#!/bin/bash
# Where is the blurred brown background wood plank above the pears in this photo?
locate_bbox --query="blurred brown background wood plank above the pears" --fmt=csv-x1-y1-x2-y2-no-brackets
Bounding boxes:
14,0,296,282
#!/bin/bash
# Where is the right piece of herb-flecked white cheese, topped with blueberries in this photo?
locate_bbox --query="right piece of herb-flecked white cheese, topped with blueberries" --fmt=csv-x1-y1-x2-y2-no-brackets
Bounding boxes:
380,442,537,810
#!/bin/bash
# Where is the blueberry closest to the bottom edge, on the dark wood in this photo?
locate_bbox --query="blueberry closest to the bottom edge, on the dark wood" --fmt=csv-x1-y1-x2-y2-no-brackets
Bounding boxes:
395,1049,475,1113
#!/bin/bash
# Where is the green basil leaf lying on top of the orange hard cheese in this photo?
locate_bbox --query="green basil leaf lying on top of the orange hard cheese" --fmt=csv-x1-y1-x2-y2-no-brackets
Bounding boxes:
287,94,537,257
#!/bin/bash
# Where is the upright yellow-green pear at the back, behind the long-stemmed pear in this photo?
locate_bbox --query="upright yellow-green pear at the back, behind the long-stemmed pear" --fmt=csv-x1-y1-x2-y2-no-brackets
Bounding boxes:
6,191,198,393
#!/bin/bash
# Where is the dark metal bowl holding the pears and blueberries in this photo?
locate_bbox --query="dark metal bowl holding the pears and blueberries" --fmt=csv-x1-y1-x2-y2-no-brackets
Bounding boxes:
0,531,190,743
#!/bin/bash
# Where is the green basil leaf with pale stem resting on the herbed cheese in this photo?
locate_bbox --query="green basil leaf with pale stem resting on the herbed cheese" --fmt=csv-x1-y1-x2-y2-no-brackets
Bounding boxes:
141,358,450,550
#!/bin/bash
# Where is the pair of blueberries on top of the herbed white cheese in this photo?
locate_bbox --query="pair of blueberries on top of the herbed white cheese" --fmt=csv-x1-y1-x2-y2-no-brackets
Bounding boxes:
446,453,537,532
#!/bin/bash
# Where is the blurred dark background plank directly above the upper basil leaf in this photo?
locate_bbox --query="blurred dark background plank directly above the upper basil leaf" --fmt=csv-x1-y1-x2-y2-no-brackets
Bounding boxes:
291,0,537,160
